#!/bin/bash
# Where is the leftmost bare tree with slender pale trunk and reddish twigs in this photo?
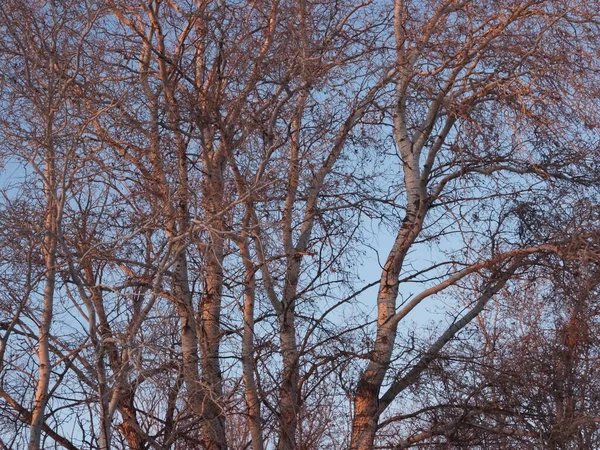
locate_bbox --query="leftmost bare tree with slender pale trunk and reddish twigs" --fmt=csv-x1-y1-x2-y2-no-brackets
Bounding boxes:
0,2,103,450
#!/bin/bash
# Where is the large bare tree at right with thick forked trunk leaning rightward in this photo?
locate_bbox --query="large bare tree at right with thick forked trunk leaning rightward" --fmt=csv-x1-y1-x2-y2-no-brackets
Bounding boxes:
351,0,597,449
